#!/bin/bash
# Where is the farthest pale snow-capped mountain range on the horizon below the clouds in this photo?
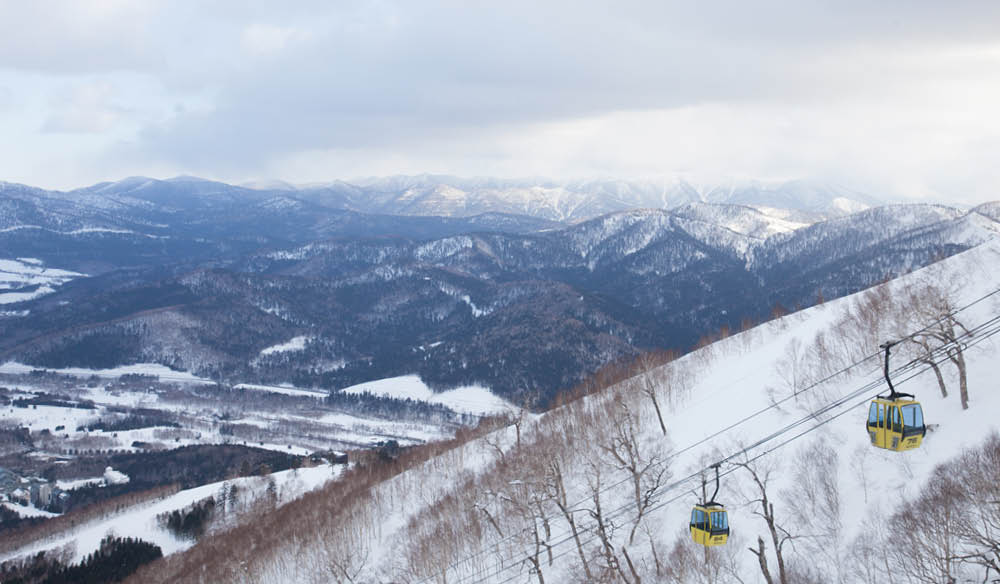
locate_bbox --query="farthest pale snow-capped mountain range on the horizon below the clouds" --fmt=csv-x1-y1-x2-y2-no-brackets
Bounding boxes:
255,174,886,222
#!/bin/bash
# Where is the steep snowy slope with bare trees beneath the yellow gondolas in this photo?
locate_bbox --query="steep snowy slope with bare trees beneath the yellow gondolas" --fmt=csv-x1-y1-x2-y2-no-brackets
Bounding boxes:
143,237,1000,583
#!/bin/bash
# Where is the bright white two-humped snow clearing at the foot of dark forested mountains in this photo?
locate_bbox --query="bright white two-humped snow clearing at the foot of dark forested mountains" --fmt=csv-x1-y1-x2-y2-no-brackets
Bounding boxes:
341,375,517,414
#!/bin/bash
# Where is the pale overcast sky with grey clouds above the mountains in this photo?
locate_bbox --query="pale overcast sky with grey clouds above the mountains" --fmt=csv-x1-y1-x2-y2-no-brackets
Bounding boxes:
0,0,1000,202
